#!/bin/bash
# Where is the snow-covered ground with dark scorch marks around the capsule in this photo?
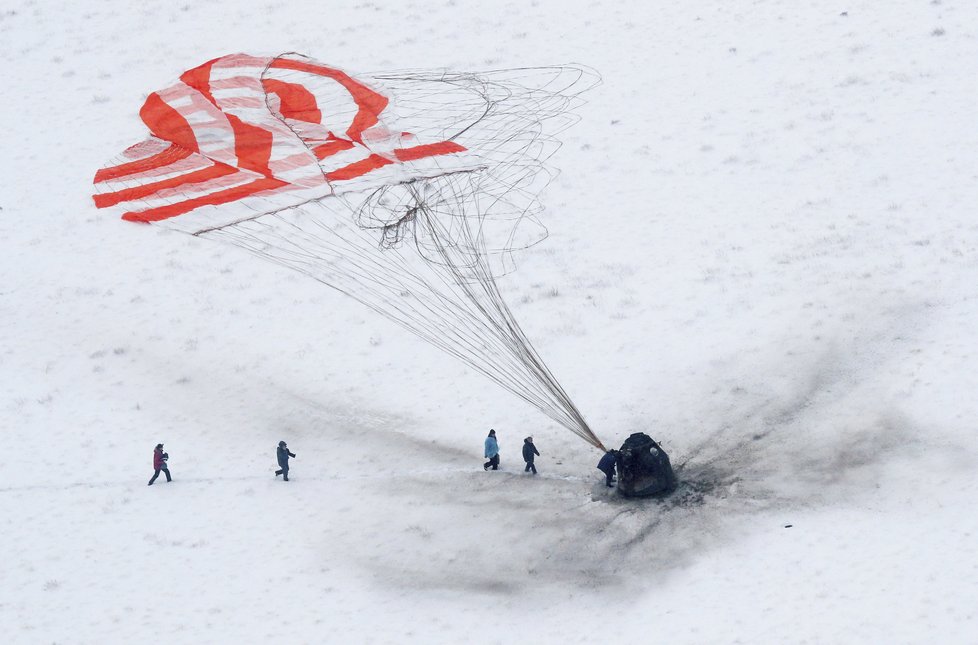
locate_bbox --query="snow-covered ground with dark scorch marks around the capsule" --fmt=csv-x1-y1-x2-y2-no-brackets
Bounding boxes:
0,0,978,643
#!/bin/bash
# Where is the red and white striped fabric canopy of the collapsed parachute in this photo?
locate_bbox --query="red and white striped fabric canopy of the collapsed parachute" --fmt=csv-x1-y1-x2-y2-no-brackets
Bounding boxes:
95,54,472,233
